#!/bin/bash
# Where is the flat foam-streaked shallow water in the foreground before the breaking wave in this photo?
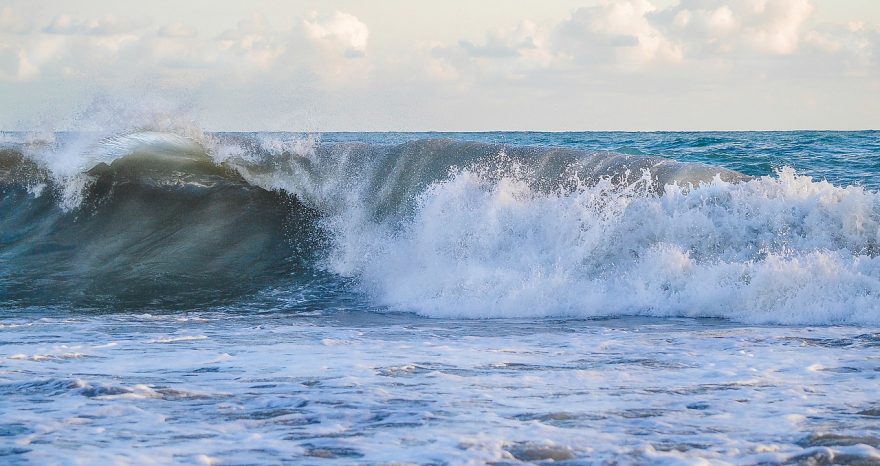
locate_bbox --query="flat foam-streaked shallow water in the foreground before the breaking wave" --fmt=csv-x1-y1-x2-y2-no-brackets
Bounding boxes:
0,312,880,464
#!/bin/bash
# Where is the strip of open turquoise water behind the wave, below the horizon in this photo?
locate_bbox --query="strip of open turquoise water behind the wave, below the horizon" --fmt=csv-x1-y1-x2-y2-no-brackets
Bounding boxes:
321,131,880,189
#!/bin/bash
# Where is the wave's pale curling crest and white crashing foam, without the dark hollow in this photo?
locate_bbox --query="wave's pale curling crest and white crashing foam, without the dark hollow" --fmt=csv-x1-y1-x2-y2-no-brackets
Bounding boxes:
8,131,880,324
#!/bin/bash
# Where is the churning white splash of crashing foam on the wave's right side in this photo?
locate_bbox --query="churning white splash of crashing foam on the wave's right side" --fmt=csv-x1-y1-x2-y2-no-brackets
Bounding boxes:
327,163,880,324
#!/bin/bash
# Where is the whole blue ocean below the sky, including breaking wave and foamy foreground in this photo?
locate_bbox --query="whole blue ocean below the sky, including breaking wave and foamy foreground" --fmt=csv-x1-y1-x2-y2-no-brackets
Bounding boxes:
0,128,880,464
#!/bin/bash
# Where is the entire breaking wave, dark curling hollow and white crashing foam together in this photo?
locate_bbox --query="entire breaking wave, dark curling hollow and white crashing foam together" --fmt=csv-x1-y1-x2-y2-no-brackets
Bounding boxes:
0,129,880,324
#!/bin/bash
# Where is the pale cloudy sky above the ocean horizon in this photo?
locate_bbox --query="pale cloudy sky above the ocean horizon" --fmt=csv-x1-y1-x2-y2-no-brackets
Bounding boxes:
0,0,880,131
